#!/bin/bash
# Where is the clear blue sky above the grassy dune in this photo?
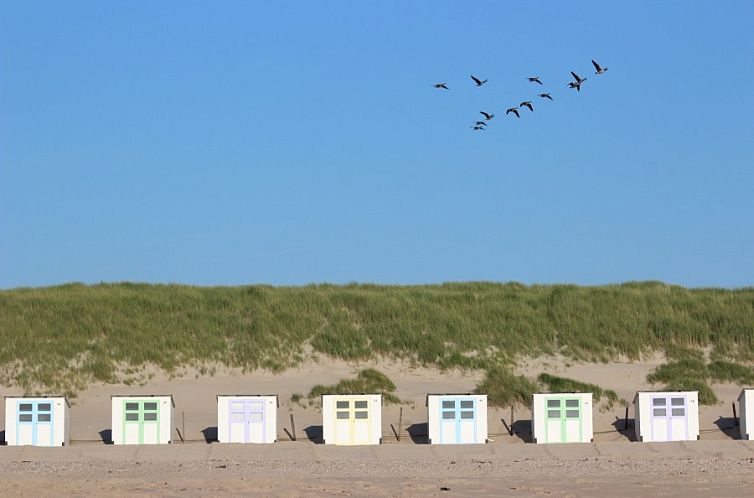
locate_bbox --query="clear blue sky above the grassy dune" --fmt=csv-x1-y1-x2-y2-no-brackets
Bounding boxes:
0,0,754,288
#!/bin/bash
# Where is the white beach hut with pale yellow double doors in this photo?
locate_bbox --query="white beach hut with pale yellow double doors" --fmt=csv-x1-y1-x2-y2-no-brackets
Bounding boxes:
322,394,382,445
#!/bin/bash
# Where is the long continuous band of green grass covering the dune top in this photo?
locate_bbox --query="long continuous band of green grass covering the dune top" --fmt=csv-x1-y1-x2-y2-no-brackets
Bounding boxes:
0,282,754,392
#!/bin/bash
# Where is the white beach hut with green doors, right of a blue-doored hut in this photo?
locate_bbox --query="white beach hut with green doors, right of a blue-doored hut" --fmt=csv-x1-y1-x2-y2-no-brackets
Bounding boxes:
531,393,594,443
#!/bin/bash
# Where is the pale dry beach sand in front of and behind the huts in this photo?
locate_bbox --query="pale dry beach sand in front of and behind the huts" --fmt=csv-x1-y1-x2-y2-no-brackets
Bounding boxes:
0,358,754,496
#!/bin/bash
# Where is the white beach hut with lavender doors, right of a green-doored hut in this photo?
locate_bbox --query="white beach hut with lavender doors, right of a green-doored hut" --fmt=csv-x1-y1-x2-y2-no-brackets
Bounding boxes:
634,391,699,443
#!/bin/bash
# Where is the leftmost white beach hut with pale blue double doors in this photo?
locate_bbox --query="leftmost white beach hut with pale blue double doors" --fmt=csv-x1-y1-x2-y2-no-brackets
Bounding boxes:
5,396,70,446
